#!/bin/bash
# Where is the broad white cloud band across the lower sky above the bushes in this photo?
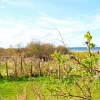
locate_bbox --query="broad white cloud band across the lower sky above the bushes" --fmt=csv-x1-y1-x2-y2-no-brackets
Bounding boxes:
0,12,100,47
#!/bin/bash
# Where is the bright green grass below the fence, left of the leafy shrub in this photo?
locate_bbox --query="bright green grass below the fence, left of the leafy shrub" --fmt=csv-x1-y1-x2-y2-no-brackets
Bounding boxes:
0,77,63,100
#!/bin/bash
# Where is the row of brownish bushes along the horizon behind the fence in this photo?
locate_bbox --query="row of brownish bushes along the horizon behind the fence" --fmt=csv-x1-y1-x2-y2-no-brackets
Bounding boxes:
0,41,68,59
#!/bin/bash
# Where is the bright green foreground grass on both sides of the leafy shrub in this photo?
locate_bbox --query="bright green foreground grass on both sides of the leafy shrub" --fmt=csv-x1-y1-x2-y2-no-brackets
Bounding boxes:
0,76,100,100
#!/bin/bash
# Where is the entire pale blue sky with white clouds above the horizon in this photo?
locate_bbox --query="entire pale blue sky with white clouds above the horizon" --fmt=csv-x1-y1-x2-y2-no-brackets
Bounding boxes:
0,0,100,48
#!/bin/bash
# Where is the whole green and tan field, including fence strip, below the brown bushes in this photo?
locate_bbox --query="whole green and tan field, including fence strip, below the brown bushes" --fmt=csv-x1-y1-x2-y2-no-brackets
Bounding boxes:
0,52,100,100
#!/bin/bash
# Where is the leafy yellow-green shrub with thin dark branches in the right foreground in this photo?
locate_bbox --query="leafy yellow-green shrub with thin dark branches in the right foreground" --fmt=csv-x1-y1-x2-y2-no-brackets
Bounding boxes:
49,32,98,100
